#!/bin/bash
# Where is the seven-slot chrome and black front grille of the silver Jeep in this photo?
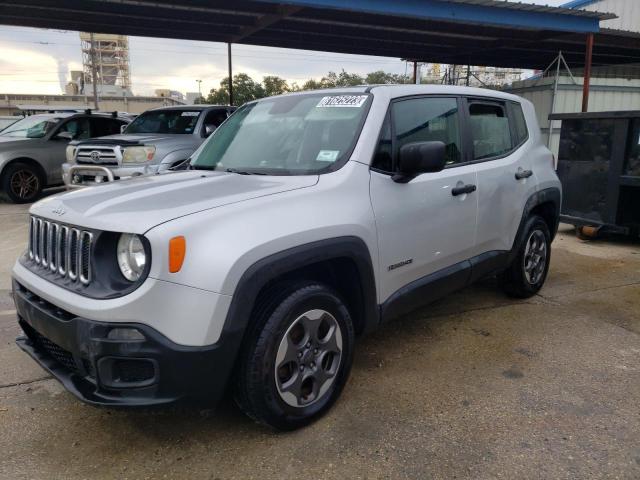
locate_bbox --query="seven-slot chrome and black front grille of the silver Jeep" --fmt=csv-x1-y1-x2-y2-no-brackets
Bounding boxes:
29,216,93,285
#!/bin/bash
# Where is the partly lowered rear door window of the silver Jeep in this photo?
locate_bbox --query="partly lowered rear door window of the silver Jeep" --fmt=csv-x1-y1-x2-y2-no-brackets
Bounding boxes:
469,102,512,160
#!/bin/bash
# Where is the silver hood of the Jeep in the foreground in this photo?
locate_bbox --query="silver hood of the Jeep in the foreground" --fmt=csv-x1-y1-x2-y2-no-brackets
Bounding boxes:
30,171,318,233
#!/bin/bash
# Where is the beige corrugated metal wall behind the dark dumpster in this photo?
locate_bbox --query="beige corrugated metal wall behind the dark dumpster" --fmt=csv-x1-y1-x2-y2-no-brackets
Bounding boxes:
507,75,640,154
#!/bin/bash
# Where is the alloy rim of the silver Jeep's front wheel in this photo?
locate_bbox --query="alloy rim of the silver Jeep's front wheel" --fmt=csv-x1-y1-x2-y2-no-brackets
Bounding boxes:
275,309,342,407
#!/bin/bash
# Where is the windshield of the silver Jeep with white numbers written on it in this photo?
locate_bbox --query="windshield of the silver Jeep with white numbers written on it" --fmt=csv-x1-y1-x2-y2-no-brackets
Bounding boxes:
192,93,370,175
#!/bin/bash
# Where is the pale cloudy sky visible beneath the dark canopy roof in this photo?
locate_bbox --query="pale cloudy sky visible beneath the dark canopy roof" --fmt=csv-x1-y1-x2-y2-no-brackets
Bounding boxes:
0,0,566,95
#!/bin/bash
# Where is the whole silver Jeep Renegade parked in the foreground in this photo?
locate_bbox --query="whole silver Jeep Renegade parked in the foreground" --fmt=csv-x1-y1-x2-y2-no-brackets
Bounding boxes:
13,85,561,429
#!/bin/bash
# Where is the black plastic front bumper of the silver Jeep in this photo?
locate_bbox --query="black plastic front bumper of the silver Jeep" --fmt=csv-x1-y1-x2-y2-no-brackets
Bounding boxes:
13,280,240,406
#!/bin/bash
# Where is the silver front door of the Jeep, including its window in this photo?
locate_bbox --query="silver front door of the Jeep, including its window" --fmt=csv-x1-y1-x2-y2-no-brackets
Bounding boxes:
370,96,478,301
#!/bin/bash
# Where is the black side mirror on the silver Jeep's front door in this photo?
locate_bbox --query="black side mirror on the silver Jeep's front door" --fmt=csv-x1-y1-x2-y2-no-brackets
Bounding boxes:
392,142,447,183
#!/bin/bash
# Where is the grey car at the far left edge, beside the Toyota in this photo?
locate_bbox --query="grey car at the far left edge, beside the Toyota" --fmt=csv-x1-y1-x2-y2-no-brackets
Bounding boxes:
0,111,129,203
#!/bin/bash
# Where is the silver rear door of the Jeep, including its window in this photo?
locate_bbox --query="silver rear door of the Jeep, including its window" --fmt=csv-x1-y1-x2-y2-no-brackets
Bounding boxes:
466,98,535,255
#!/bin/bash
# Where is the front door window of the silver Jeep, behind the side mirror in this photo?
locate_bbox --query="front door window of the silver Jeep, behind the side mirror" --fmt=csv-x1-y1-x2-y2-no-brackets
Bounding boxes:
391,97,462,165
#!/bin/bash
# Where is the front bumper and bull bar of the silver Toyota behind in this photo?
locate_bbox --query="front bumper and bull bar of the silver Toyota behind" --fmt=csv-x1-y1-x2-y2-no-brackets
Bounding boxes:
62,163,158,190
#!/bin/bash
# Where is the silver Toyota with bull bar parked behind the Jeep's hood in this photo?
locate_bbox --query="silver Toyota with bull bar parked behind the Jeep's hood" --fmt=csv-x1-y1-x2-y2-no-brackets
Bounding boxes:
62,105,236,189
